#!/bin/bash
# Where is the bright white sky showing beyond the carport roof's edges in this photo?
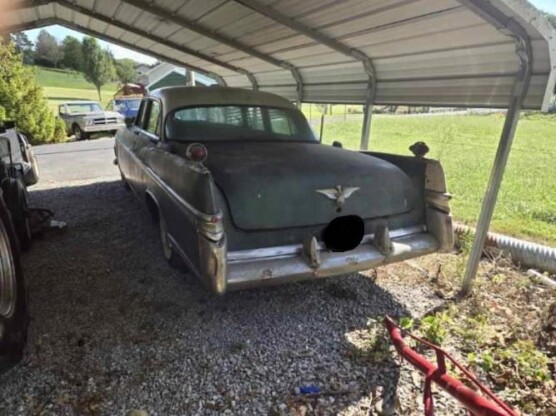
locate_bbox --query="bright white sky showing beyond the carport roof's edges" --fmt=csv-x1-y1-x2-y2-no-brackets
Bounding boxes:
25,0,556,65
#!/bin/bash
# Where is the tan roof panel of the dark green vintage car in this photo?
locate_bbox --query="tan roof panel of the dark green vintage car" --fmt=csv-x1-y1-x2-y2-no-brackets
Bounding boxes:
149,86,297,113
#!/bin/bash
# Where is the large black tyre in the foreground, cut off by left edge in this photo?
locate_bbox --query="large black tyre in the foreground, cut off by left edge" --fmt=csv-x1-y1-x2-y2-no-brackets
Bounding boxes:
0,198,29,373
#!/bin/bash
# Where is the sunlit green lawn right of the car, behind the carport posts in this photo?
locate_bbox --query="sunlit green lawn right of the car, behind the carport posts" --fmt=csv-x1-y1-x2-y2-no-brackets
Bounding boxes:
323,114,556,246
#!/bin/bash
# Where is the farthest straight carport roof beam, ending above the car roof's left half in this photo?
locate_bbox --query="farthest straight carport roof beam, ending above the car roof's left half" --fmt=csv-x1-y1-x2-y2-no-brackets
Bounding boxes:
48,0,255,88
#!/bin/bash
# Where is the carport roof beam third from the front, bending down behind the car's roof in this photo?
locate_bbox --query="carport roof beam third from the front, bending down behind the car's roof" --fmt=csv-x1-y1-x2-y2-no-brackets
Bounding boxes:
117,0,303,97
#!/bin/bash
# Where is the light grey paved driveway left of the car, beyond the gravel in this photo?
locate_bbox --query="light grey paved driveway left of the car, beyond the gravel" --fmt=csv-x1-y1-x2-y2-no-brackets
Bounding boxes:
33,137,119,184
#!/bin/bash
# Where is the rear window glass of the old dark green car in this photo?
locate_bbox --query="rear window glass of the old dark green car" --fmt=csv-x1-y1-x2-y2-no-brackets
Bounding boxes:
166,105,317,142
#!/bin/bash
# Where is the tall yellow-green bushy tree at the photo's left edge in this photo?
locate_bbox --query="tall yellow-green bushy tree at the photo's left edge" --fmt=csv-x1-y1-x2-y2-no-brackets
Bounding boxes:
0,43,65,143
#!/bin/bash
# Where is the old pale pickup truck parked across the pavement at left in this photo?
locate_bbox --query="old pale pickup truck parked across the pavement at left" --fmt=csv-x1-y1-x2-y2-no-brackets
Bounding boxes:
58,101,125,140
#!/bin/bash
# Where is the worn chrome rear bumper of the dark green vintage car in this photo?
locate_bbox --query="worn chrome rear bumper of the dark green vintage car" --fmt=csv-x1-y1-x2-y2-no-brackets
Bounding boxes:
195,227,442,294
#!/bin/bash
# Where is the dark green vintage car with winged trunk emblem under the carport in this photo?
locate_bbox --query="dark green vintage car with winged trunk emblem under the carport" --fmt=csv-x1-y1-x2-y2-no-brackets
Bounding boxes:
115,87,453,293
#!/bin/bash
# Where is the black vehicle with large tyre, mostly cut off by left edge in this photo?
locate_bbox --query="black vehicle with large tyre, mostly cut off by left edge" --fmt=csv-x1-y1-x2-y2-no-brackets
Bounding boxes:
0,121,30,373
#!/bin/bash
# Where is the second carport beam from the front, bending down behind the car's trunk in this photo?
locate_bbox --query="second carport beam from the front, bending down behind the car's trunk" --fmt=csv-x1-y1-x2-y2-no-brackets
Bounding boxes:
233,0,377,136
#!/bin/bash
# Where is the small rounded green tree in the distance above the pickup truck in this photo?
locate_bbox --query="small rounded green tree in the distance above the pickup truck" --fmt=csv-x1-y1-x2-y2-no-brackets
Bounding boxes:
82,37,115,100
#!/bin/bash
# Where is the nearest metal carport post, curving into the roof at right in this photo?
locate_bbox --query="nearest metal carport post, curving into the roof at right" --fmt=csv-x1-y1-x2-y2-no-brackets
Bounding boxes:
458,0,533,296
